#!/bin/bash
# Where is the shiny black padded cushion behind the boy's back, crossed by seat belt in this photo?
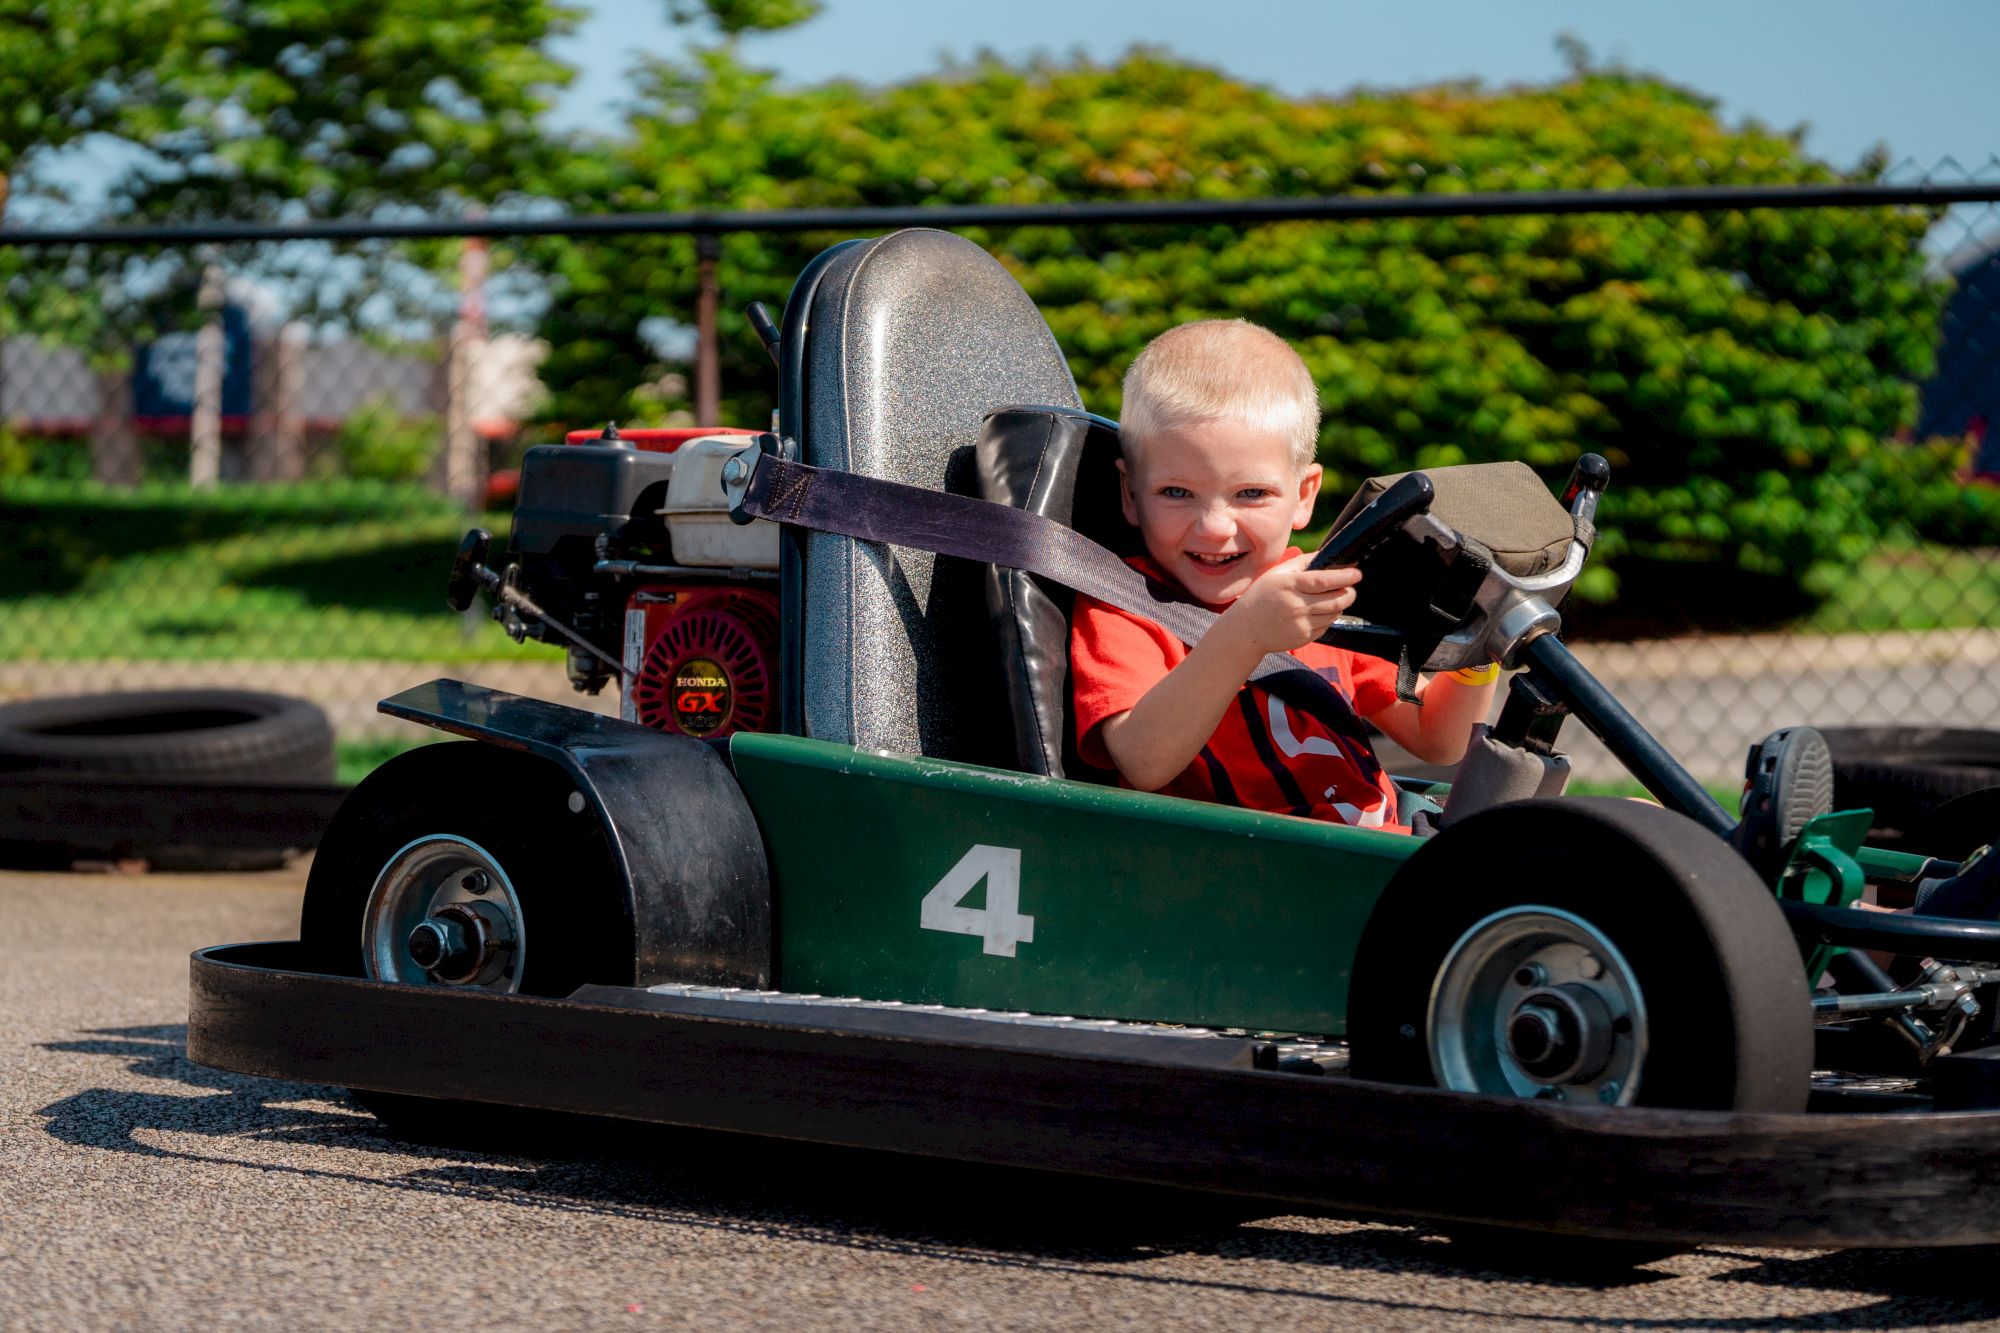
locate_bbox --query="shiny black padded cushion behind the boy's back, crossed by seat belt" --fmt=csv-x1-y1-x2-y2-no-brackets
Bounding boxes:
970,406,1140,781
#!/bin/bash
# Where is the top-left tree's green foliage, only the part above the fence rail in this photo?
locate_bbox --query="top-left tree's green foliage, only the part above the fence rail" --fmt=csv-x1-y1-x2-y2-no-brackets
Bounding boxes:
0,0,576,218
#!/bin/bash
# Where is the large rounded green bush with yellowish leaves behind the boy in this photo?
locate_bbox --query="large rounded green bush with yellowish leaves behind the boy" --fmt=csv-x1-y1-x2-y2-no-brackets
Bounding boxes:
544,40,1940,590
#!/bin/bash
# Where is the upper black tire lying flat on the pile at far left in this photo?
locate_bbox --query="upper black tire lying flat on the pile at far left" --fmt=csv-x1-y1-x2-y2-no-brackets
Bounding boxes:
0,689,334,783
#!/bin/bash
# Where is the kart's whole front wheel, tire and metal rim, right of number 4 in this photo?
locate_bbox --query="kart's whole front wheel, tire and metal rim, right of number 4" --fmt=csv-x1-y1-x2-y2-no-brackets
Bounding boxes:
1348,797,1812,1111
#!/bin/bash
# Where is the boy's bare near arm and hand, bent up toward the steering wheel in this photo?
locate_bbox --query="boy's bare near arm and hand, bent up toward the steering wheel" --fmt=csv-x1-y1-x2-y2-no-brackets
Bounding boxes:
1098,556,1360,791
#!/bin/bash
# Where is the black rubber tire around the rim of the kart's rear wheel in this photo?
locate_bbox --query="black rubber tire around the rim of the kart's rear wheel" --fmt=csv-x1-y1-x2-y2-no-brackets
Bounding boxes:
298,741,632,997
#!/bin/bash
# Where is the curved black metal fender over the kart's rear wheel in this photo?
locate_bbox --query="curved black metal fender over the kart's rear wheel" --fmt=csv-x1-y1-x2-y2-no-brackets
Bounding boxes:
378,681,774,989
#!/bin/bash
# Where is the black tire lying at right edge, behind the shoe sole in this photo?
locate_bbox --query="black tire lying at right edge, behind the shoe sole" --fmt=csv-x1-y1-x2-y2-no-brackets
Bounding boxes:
1820,727,2000,851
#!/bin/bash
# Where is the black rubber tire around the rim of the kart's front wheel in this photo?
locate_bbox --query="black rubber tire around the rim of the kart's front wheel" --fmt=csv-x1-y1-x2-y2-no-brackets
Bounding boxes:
1348,797,1812,1111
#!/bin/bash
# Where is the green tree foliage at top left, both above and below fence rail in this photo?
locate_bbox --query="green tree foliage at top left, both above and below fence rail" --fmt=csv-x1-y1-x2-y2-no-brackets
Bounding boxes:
0,0,576,356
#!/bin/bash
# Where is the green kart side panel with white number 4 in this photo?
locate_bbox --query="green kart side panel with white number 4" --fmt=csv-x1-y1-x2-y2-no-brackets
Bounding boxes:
730,733,1418,1035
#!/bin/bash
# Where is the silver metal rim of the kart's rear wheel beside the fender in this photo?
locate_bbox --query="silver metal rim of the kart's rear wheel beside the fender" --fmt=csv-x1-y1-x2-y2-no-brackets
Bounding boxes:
362,833,528,995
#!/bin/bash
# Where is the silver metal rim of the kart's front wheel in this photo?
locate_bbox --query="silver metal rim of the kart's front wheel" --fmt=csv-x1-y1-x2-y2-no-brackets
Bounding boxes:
1426,905,1648,1107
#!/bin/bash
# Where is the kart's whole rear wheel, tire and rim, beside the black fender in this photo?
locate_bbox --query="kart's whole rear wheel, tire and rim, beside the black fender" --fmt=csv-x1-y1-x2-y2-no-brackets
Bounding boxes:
300,743,632,997
